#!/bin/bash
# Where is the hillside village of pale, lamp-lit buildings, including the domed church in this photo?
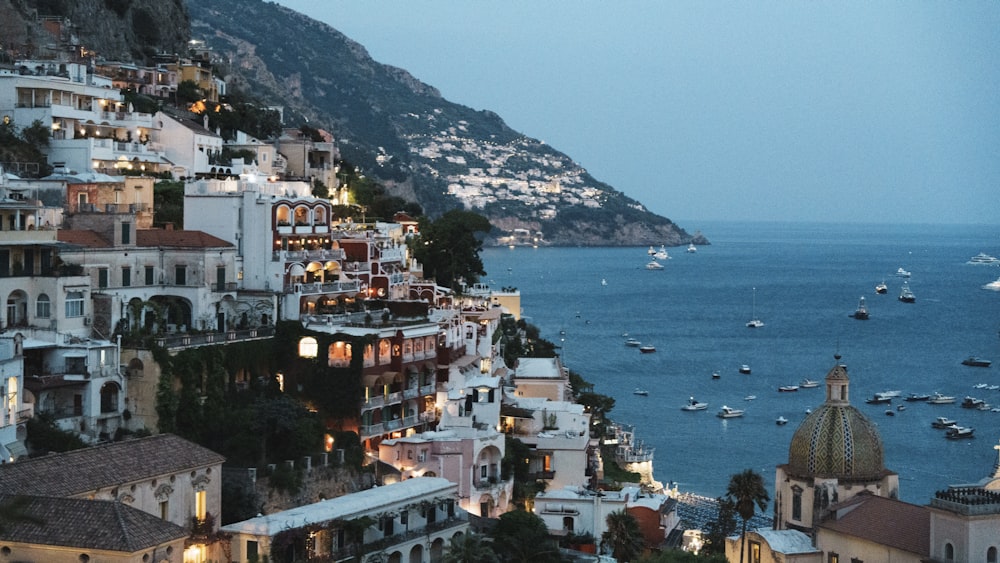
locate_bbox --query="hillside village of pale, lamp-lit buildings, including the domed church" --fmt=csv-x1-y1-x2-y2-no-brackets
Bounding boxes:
0,13,1000,563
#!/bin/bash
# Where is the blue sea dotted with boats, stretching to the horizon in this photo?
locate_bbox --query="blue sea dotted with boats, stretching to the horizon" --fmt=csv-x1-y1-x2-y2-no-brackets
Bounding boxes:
482,222,1000,504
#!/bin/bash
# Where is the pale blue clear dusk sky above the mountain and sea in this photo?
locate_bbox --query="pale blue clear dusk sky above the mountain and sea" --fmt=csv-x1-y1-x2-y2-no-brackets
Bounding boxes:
270,0,1000,226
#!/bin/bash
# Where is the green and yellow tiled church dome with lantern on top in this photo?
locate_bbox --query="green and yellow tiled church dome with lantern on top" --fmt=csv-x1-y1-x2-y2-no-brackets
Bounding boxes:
788,356,885,480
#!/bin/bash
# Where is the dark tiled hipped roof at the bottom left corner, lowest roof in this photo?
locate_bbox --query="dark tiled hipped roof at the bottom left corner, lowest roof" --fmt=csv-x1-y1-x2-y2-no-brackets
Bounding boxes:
0,495,188,553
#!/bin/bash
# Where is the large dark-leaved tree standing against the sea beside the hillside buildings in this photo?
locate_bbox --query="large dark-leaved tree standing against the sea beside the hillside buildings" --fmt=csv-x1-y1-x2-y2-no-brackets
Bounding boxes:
410,209,492,289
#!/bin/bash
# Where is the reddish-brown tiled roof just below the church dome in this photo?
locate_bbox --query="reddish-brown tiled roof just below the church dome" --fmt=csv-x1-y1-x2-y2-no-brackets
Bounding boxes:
817,494,931,557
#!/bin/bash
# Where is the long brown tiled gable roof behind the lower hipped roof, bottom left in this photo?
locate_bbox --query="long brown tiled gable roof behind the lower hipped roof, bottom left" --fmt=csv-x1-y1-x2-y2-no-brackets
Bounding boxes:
0,434,225,497
